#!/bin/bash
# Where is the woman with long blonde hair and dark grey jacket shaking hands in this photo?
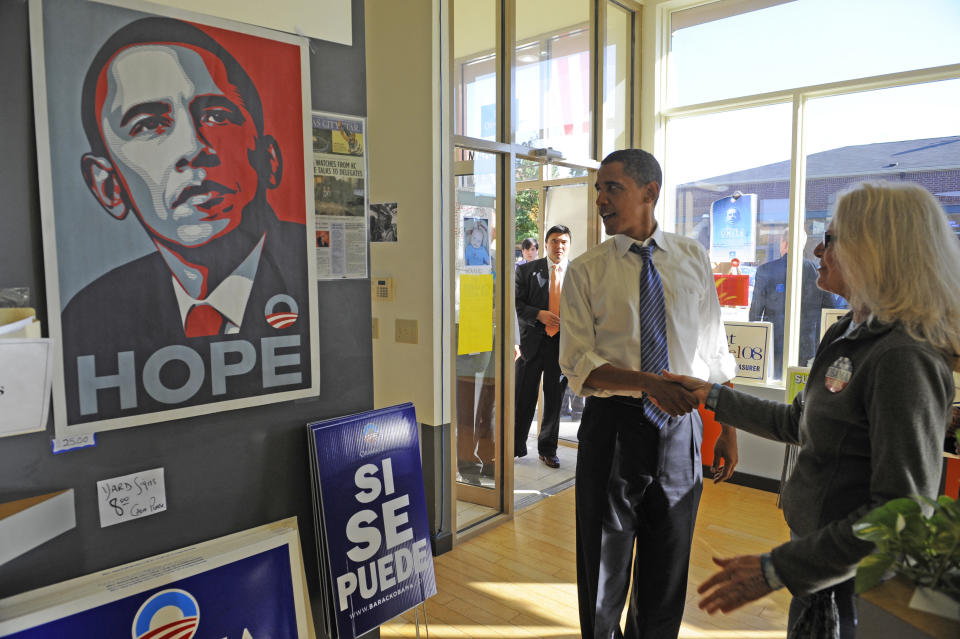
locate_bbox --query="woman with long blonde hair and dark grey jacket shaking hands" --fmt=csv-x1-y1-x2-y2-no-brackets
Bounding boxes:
665,183,960,639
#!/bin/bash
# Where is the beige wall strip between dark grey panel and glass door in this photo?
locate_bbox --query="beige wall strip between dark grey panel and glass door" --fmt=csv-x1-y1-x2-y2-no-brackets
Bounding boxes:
365,0,449,425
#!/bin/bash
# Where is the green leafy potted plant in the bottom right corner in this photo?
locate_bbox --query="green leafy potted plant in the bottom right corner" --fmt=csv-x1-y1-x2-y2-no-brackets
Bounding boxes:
853,495,960,618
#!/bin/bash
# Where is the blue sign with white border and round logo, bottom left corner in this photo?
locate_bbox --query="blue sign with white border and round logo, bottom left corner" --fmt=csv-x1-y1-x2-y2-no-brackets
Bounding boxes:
0,517,312,639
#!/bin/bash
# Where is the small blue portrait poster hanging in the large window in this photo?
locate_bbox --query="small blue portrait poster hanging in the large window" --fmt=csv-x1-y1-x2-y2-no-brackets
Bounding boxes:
710,191,757,263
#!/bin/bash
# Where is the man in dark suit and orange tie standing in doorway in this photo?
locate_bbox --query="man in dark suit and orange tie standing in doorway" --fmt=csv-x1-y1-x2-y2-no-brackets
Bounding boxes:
514,225,570,468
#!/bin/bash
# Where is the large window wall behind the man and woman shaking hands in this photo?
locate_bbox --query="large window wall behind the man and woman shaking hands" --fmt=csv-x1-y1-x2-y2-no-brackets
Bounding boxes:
661,0,960,381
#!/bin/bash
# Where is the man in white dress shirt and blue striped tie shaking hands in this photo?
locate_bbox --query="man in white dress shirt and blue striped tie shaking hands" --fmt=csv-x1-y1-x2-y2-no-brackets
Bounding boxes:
560,149,737,639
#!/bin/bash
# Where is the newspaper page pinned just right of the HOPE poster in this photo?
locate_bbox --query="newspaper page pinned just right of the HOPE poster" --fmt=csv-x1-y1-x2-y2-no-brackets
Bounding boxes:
312,112,368,280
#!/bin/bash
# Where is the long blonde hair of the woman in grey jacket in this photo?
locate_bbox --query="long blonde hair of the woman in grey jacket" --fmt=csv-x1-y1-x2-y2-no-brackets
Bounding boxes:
833,182,960,367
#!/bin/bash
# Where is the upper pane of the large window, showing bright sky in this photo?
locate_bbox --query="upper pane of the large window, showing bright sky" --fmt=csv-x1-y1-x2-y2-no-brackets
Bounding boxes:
669,0,960,106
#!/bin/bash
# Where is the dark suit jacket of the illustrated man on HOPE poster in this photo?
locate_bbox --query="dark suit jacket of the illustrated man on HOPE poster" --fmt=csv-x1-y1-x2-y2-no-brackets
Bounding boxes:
61,216,314,423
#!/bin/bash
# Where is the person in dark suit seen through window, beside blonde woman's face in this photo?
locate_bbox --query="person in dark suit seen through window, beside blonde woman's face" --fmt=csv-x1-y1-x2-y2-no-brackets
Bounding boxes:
750,230,837,379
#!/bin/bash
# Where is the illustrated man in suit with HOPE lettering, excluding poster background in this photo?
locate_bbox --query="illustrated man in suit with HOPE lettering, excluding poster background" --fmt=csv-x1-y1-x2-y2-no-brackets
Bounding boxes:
61,18,311,423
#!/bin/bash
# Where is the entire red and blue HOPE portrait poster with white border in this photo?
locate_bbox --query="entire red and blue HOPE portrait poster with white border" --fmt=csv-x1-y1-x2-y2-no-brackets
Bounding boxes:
30,0,320,438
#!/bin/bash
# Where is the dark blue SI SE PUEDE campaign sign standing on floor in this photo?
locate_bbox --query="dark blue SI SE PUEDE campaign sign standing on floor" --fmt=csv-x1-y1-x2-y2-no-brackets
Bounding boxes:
308,404,437,639
